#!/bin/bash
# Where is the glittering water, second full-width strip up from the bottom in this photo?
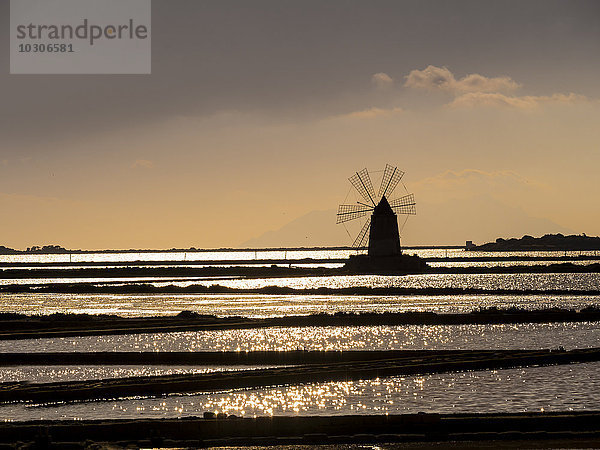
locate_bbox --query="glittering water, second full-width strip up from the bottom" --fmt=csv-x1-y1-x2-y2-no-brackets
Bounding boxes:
0,322,600,353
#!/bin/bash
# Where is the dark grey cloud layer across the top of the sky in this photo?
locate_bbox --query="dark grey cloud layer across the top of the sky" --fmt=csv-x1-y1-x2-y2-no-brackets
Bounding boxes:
0,0,600,156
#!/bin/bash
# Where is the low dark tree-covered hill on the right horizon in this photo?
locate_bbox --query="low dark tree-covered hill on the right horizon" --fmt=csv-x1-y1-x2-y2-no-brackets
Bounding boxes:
473,234,600,251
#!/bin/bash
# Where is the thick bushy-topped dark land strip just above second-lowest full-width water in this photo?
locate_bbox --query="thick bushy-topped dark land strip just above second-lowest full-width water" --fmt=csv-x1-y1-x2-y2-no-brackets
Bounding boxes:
0,306,600,340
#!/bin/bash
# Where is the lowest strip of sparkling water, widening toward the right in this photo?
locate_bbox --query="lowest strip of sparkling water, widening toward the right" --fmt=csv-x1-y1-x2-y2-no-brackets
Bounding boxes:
0,362,600,420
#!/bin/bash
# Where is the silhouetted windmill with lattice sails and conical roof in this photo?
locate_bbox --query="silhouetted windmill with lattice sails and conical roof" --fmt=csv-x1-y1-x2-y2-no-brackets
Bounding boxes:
336,164,417,257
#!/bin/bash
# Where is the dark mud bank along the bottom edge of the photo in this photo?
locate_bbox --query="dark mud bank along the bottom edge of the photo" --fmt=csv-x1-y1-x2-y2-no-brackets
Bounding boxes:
0,411,600,449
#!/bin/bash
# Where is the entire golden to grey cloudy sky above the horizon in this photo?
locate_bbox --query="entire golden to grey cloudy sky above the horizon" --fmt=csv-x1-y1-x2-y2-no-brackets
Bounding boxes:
0,0,600,249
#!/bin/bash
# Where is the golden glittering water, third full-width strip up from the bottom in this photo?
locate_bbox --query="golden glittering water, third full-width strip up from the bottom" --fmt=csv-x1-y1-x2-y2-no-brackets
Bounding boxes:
0,294,600,317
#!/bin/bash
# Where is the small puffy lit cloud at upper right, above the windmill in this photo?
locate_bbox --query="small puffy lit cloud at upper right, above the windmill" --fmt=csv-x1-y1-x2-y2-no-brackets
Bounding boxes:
404,65,520,95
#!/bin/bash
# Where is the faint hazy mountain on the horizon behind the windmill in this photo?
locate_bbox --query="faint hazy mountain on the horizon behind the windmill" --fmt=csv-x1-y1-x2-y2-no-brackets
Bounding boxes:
241,196,574,248
